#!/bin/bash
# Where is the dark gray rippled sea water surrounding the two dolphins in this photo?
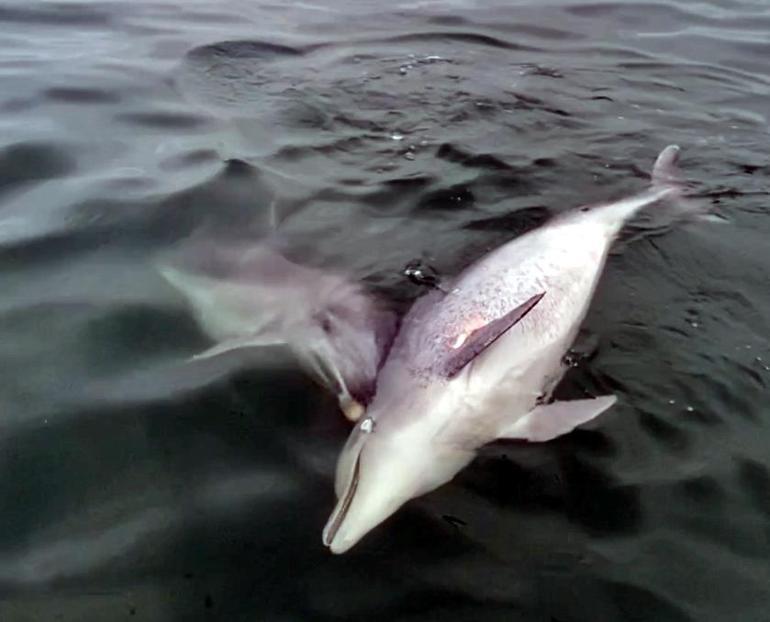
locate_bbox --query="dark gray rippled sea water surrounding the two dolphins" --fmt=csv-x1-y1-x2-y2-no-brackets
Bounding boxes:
0,0,770,622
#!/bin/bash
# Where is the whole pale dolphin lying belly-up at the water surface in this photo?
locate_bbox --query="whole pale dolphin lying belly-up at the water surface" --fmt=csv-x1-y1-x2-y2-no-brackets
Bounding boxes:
323,145,694,553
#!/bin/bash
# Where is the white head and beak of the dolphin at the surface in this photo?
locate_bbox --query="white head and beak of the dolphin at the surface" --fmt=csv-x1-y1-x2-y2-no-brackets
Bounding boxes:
323,416,474,554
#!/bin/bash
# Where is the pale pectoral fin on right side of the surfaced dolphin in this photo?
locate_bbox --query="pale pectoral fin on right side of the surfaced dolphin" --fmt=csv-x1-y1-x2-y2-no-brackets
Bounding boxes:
498,395,617,443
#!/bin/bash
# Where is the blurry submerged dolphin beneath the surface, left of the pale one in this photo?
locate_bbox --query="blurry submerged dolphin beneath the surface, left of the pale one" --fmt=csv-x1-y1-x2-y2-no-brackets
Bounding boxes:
159,240,395,420
